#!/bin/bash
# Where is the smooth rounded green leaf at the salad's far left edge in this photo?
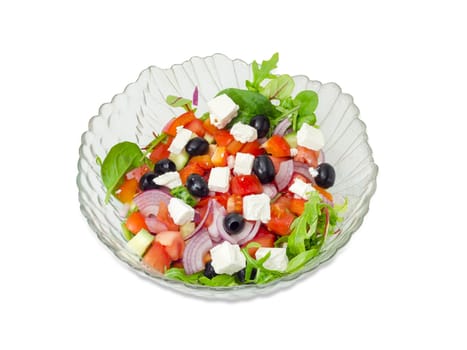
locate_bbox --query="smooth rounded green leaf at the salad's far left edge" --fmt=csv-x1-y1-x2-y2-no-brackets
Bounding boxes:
101,141,145,203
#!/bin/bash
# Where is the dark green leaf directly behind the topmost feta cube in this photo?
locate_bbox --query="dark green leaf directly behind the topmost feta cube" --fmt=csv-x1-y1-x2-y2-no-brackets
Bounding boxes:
217,88,278,126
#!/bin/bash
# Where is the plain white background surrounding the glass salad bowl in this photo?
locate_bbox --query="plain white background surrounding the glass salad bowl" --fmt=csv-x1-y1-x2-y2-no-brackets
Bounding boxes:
0,0,467,349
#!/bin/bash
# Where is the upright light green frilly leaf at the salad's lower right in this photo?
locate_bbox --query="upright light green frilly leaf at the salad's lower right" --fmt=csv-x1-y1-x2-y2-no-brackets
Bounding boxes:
287,191,321,257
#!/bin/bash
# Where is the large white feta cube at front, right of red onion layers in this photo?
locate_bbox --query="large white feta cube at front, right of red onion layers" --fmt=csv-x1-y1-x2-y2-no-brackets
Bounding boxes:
210,241,246,275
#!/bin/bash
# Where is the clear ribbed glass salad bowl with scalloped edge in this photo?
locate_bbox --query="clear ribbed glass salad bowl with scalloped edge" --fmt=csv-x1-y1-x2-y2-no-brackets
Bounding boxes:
77,54,378,299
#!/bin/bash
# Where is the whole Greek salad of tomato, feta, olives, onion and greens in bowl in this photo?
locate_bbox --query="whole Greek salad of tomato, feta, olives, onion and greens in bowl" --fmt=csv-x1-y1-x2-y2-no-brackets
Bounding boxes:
97,53,346,287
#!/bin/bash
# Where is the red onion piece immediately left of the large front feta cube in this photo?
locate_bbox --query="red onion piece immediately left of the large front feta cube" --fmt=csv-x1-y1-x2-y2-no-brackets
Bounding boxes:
183,229,213,275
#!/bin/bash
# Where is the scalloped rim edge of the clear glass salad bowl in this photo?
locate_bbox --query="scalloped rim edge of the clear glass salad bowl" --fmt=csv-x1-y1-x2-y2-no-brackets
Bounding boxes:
76,53,378,300
